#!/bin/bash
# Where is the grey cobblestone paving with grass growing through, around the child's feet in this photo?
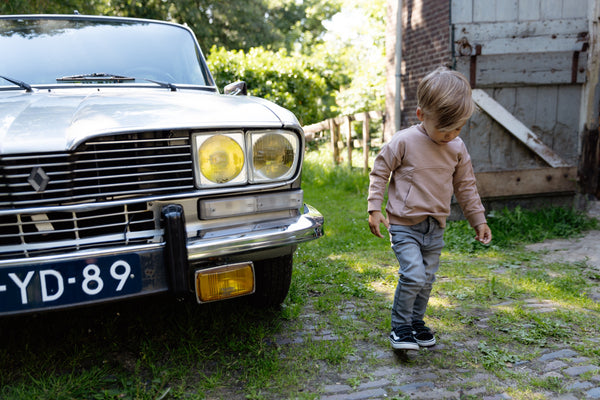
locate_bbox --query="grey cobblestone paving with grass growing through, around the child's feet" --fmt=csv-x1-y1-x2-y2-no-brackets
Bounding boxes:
277,202,600,400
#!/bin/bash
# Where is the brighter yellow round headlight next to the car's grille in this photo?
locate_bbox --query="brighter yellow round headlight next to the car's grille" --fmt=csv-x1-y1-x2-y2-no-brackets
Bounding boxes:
198,135,244,183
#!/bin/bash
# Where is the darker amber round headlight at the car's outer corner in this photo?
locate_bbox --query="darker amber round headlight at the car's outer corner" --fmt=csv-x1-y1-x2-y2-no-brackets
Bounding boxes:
252,133,294,179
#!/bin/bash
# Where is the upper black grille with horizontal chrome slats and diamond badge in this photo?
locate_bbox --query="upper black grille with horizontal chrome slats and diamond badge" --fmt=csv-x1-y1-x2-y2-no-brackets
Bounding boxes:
0,131,194,208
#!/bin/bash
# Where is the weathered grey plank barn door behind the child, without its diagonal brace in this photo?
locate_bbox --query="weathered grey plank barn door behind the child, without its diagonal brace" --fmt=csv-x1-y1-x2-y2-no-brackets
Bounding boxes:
451,0,589,172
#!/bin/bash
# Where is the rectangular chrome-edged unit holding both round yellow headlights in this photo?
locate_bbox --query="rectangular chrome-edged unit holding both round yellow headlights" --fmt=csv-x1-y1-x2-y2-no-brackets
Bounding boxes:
192,130,301,188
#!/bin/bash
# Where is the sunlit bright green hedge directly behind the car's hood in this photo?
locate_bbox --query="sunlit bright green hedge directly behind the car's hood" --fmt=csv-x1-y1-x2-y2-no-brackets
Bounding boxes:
207,47,340,124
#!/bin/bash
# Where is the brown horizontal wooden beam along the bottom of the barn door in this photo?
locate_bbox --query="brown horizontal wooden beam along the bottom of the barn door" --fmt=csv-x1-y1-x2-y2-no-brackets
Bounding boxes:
475,167,577,198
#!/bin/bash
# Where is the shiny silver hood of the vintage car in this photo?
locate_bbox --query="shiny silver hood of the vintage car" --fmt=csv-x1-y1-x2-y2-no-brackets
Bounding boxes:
0,88,298,154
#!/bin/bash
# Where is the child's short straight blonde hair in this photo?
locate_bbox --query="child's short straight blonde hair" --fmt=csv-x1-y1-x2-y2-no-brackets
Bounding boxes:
417,67,475,132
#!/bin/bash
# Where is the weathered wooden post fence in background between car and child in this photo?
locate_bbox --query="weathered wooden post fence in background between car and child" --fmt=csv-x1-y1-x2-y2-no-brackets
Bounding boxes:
303,111,384,171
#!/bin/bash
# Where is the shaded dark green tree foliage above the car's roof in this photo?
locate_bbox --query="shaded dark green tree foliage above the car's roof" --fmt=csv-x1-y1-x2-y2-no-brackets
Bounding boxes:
0,0,340,54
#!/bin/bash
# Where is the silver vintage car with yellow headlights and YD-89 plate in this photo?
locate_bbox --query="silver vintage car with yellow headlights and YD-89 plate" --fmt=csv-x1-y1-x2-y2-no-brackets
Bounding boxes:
0,15,323,316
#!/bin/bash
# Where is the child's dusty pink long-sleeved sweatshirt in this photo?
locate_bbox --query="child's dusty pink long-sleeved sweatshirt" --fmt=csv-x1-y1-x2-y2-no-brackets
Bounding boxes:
367,125,486,227
